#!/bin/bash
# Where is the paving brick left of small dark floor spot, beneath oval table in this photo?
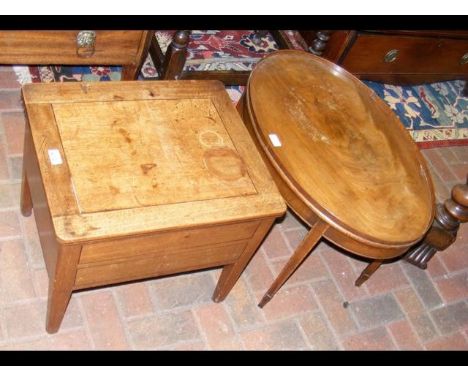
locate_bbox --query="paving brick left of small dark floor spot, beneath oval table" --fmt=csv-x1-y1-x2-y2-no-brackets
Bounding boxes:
311,280,357,335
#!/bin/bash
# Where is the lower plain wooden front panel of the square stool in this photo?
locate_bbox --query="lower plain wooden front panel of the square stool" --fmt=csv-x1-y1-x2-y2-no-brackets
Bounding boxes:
74,241,248,289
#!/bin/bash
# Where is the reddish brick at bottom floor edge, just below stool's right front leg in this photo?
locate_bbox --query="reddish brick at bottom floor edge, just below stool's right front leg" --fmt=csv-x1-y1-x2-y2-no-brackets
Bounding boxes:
194,304,242,350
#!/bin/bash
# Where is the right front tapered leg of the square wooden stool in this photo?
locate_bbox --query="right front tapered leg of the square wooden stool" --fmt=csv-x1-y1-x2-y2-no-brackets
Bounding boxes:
213,219,274,302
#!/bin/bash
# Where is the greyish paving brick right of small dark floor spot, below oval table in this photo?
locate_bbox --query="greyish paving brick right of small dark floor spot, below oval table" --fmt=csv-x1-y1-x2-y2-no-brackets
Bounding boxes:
349,294,404,329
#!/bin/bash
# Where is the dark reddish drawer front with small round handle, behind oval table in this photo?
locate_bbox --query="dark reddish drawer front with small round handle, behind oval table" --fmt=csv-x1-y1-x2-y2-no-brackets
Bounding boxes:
340,35,468,74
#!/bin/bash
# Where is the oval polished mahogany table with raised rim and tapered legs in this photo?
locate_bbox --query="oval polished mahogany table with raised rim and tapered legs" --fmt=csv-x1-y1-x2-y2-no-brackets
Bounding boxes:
238,50,434,307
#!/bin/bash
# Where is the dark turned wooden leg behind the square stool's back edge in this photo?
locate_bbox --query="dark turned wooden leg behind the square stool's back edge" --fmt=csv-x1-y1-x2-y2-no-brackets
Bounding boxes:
161,30,189,80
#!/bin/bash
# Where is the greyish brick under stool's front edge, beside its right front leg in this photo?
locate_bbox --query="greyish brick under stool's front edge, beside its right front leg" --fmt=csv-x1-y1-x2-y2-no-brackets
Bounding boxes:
150,272,215,310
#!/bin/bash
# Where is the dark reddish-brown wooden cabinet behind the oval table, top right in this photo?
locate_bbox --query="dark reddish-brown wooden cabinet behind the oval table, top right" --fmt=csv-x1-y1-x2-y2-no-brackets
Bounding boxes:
301,30,468,83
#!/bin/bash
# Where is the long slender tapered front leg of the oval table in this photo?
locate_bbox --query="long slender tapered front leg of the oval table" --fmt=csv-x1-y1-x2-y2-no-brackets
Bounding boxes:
258,220,328,308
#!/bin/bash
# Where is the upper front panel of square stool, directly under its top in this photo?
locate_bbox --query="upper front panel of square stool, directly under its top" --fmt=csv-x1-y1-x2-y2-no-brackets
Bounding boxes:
80,221,260,265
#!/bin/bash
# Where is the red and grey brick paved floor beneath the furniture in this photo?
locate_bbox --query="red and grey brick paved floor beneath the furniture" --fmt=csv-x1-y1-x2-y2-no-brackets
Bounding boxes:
0,66,468,350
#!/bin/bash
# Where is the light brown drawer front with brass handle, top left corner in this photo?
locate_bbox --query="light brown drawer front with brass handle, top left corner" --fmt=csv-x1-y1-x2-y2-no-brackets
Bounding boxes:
0,30,144,65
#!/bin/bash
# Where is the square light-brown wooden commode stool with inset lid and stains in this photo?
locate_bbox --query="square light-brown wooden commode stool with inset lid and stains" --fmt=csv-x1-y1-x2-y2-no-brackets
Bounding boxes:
21,81,286,333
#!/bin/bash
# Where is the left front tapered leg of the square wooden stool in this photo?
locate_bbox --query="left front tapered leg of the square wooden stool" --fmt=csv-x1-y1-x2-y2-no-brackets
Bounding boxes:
46,245,82,333
